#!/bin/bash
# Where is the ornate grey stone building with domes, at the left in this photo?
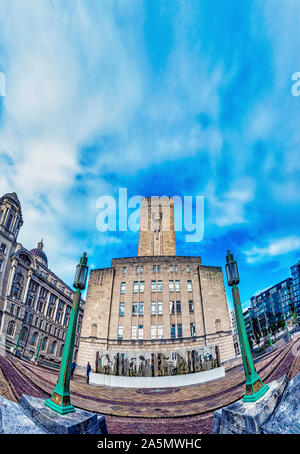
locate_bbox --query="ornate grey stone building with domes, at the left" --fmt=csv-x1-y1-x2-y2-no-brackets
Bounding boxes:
0,193,84,363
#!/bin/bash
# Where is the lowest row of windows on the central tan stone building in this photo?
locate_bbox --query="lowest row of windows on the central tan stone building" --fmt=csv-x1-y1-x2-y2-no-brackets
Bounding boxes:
118,322,196,340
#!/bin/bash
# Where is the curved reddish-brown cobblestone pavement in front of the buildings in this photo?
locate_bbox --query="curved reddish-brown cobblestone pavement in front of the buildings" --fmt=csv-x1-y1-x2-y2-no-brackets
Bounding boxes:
0,339,300,434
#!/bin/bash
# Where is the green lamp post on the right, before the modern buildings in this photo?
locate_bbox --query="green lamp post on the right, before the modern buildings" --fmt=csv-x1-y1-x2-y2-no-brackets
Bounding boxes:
226,251,269,402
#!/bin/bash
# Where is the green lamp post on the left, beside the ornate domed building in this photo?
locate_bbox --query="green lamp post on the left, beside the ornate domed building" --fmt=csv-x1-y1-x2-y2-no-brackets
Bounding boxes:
45,252,88,415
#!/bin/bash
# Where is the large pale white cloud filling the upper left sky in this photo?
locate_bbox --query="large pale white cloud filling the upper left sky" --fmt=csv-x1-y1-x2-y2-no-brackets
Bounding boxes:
0,0,143,284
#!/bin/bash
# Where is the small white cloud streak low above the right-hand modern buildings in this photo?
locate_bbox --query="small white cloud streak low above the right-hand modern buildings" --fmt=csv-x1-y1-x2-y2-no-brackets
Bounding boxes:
244,236,300,263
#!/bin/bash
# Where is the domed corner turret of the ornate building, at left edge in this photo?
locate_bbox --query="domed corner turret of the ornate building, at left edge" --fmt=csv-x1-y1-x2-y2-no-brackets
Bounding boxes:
0,192,23,242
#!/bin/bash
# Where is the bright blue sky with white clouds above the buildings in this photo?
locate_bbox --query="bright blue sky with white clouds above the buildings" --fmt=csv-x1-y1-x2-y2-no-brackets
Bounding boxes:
0,0,300,304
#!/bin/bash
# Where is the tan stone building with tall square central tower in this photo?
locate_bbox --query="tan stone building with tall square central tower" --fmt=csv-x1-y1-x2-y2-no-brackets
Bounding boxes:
78,197,235,374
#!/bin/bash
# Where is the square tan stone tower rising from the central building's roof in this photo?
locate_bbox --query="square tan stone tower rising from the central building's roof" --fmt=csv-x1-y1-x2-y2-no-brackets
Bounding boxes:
138,197,176,256
